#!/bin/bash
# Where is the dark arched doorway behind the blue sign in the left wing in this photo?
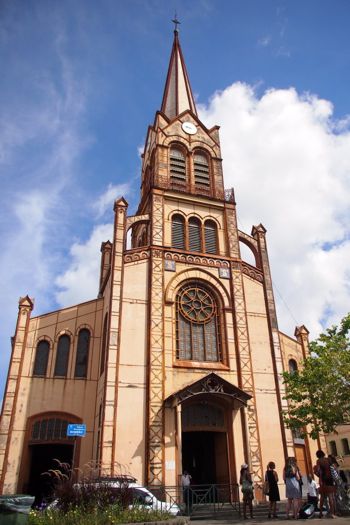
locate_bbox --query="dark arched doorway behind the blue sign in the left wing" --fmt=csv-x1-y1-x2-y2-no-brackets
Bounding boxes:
22,413,79,504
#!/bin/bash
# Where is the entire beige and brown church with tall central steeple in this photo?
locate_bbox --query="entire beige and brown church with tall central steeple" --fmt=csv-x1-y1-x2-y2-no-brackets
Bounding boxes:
0,29,324,500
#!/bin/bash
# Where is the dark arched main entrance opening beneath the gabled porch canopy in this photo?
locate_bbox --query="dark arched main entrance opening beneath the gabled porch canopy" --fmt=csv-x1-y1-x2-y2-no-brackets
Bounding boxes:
181,399,230,485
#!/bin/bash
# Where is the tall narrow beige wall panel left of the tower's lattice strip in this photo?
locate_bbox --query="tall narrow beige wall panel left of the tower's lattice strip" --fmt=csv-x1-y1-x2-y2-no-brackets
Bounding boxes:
114,260,149,481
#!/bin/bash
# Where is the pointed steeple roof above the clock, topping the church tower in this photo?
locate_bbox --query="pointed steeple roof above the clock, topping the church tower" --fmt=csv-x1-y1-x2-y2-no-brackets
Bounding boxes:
161,29,197,119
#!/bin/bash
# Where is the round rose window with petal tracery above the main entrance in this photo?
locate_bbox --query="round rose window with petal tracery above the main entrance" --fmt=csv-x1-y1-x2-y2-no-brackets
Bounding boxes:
179,287,215,323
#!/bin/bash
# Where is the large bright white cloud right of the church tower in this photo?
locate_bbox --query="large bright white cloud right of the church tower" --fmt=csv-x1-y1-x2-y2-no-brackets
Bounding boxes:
200,83,350,336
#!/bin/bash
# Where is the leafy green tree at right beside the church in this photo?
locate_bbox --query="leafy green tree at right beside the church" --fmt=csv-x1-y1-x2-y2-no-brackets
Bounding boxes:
283,313,350,438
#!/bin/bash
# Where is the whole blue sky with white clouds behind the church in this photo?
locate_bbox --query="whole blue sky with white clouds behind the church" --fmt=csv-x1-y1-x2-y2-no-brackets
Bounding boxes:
0,0,350,398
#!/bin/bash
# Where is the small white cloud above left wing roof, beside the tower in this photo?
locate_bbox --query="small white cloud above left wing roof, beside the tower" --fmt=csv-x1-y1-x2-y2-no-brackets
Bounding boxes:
56,224,113,306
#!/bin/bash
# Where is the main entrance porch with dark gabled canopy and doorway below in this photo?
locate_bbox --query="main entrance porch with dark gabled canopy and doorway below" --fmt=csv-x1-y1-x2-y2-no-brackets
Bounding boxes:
165,372,251,484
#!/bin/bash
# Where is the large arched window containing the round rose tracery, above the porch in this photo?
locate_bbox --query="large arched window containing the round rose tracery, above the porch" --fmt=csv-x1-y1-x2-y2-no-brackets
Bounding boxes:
176,281,221,362
